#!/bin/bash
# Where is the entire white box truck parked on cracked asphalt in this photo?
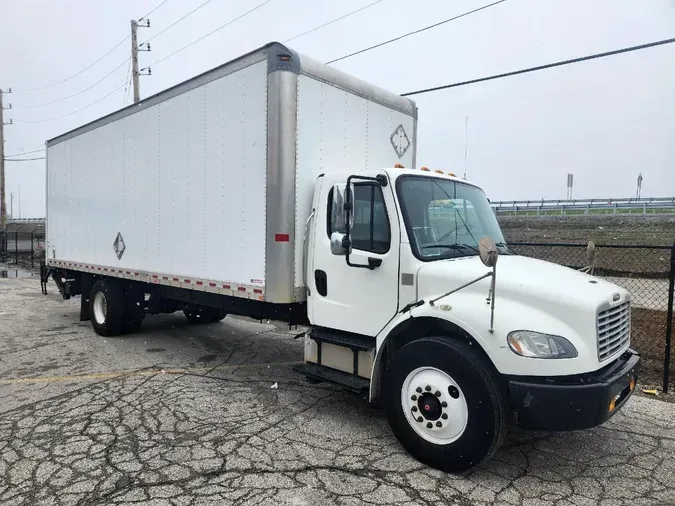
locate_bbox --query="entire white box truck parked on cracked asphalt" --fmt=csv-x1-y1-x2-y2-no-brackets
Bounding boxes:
42,43,640,471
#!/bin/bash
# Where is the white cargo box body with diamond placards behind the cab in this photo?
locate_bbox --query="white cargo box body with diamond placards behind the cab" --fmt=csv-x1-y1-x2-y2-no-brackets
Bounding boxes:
47,43,417,303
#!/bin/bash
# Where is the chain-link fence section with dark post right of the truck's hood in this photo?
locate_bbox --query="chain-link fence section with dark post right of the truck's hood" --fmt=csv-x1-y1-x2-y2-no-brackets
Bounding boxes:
509,242,675,392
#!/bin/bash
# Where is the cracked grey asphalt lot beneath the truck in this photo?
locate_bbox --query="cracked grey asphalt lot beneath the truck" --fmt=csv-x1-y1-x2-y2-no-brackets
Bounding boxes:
0,278,675,506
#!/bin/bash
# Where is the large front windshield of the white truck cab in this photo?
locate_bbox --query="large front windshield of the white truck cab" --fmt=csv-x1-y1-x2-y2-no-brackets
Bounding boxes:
398,176,508,260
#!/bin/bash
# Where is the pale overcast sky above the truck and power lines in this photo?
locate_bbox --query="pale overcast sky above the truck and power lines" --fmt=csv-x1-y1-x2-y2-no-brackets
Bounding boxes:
0,0,675,217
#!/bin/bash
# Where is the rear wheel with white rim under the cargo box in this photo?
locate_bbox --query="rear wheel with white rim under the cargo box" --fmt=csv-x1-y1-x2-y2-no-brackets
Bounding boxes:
89,279,125,337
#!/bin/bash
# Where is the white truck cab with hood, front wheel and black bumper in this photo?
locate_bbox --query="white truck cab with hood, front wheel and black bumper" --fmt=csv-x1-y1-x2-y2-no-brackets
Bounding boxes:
297,167,640,471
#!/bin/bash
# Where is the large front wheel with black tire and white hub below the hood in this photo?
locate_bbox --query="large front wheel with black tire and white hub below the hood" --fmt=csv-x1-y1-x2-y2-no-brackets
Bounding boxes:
384,337,507,472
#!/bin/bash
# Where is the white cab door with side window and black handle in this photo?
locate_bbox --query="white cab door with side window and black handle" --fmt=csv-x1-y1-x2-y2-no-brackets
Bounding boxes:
307,176,400,336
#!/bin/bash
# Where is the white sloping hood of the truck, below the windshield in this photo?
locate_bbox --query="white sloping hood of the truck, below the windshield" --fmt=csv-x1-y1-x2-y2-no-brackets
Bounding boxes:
418,255,629,315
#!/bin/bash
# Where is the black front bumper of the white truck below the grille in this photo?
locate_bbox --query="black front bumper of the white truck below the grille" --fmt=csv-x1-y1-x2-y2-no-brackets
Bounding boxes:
507,349,640,430
